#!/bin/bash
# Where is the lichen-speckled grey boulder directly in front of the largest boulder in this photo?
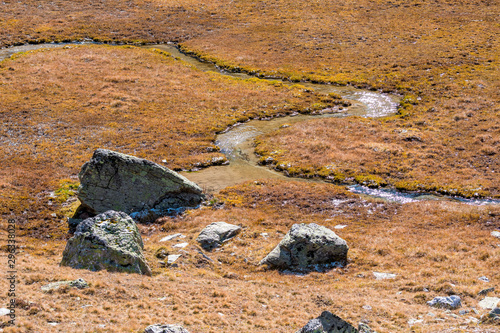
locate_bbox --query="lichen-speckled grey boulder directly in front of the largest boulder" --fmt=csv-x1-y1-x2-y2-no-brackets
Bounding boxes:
61,211,151,275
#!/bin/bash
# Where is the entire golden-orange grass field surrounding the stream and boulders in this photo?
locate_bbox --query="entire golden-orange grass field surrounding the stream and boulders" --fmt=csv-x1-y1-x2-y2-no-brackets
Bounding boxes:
0,0,500,333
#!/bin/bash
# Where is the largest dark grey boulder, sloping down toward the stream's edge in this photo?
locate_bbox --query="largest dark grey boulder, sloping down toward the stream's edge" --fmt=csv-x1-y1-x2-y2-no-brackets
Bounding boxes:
75,149,204,220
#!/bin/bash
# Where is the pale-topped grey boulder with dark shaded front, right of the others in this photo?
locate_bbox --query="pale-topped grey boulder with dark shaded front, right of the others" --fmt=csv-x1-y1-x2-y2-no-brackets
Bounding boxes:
260,223,349,271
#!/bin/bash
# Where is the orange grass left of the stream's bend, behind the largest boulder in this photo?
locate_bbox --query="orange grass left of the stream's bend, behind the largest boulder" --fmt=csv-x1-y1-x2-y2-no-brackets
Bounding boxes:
0,46,332,237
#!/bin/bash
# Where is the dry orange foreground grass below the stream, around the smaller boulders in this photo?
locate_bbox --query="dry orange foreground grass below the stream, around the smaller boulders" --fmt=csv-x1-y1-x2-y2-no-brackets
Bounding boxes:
0,181,500,333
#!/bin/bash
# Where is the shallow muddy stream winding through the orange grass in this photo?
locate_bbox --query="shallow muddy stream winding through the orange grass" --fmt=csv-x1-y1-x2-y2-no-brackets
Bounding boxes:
0,41,500,205
